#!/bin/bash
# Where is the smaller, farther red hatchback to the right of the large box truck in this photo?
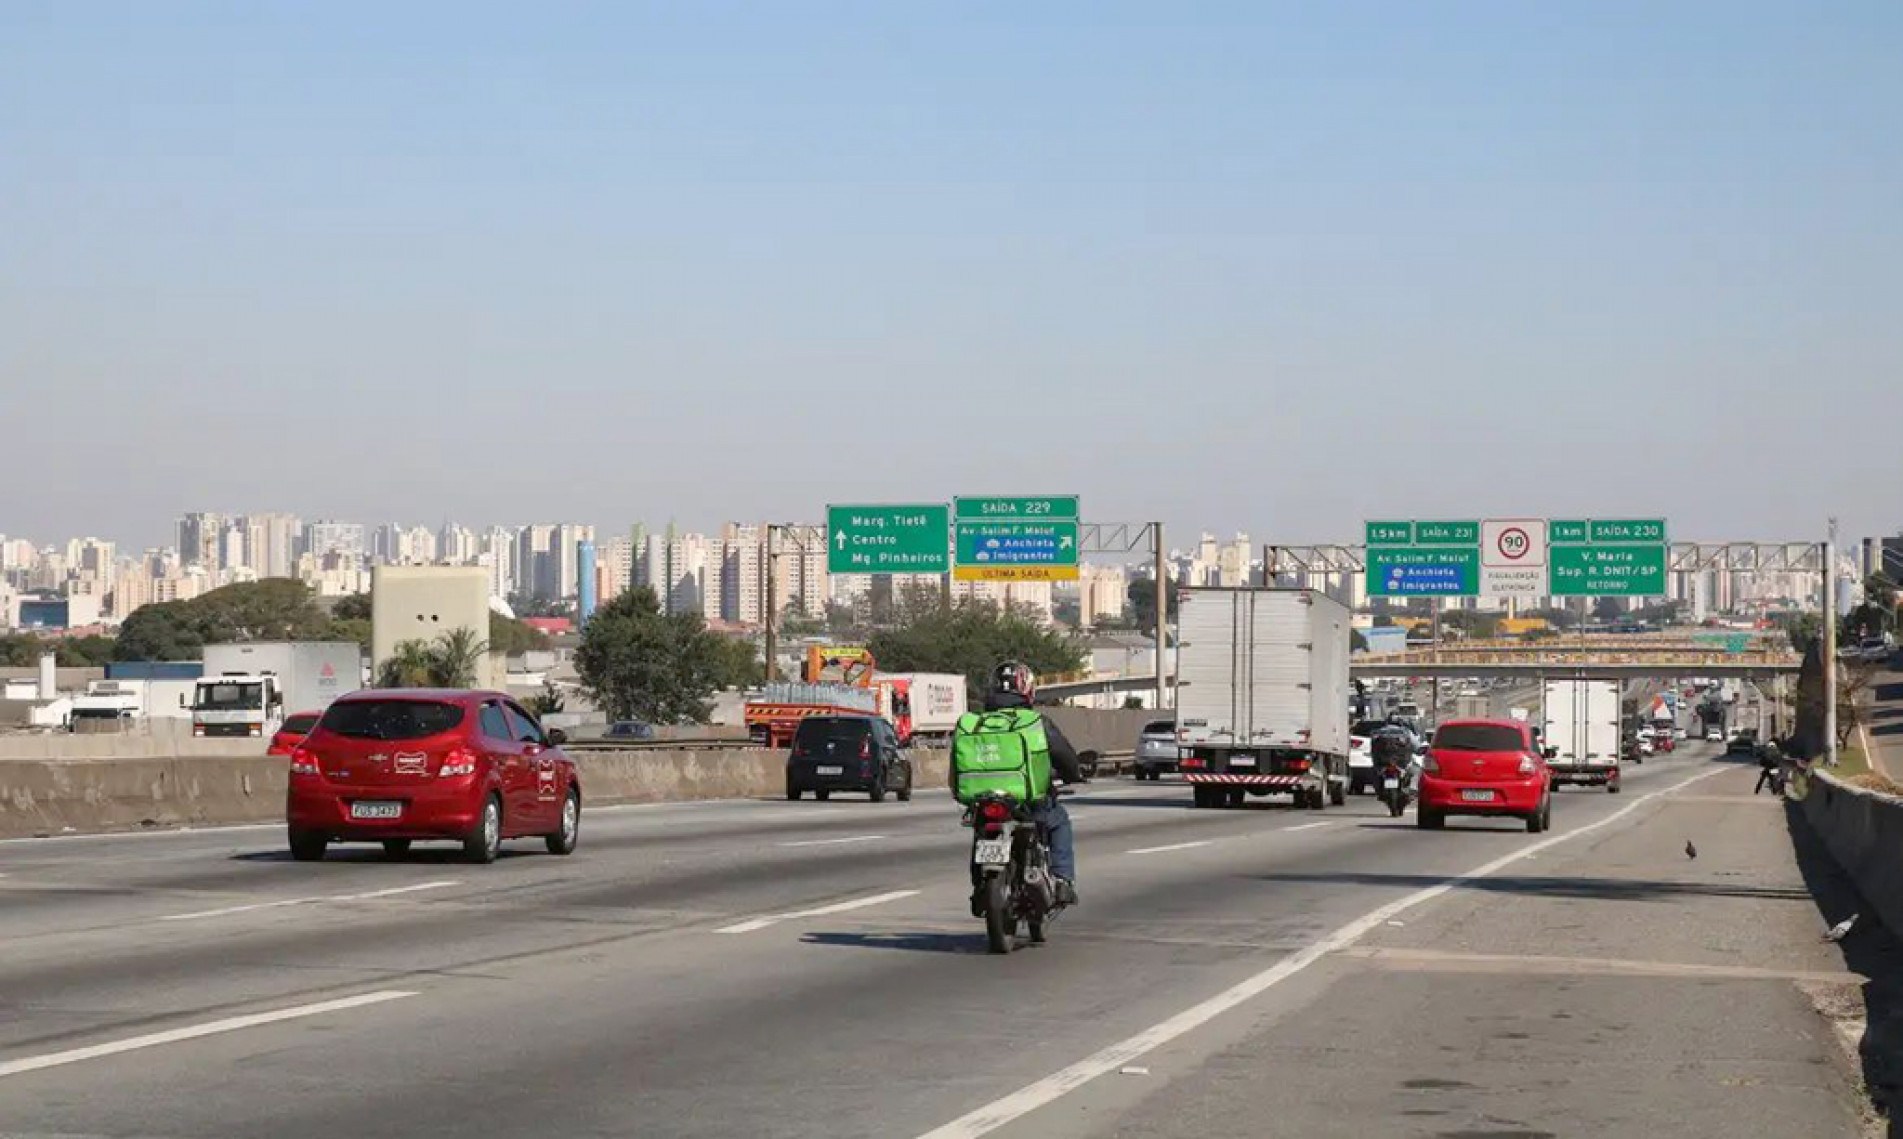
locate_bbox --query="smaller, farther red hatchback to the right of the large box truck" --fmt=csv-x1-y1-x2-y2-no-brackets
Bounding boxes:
1416,721,1553,835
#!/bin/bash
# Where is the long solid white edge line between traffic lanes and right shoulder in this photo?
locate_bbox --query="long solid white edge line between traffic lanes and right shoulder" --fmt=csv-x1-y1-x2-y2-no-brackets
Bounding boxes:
919,756,1730,1139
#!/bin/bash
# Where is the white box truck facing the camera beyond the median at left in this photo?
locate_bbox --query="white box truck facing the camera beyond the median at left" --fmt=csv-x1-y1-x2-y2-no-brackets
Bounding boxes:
192,641,363,736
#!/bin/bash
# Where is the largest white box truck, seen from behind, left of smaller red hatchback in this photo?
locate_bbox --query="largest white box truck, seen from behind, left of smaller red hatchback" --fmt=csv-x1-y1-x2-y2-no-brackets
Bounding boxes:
1176,588,1349,810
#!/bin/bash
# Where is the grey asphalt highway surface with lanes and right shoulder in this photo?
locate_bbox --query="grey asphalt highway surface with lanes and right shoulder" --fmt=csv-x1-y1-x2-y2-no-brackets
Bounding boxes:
0,747,1855,1139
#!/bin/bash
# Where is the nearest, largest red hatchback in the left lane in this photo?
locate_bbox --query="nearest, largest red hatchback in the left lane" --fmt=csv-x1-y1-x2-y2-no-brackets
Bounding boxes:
285,688,582,863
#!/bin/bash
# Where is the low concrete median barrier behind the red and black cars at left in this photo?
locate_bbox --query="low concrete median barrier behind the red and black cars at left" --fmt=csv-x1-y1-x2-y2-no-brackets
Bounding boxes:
0,749,950,839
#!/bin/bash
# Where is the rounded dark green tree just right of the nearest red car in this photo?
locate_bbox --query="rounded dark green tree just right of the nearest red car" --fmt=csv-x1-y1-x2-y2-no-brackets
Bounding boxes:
575,586,731,724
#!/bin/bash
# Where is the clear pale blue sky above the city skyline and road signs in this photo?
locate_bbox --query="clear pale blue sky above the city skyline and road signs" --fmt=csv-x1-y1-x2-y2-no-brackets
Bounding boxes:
0,0,1903,542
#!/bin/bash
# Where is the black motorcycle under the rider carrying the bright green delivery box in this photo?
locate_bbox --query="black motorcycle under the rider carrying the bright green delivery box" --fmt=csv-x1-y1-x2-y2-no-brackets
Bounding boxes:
965,795,1064,953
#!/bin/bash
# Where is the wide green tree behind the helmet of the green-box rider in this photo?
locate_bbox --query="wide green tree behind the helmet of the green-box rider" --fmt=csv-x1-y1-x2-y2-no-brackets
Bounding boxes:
868,601,1085,696
